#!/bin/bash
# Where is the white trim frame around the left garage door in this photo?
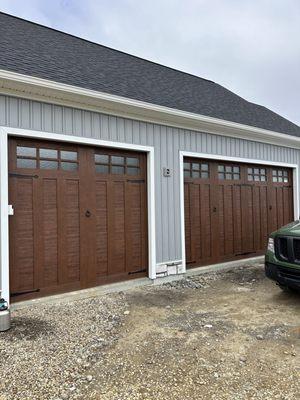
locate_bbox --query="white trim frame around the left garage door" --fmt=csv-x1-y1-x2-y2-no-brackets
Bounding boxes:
0,126,156,301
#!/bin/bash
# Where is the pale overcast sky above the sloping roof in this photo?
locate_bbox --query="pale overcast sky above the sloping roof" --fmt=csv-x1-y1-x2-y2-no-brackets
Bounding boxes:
0,0,300,125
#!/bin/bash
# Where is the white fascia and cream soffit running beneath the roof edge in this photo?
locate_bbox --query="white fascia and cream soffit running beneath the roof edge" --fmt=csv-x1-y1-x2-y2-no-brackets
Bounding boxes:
0,70,300,149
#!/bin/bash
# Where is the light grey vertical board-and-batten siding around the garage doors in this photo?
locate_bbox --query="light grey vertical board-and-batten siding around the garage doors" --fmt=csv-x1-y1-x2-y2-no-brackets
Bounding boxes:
0,95,300,263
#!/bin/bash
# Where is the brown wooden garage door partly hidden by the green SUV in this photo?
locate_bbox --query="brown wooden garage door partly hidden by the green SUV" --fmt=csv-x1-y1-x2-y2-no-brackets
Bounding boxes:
184,158,293,267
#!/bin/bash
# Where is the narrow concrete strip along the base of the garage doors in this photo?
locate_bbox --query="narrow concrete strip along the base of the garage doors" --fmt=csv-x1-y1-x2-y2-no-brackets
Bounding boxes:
10,256,264,311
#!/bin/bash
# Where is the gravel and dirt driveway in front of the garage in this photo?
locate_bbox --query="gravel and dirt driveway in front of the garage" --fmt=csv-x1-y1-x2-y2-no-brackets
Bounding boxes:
0,264,300,400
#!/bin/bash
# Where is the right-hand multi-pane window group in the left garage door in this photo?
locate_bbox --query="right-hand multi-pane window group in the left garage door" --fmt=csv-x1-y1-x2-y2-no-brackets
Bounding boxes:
95,154,141,175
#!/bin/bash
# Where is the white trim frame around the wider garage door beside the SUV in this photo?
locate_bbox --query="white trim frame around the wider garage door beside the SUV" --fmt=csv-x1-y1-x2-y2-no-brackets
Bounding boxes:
179,151,299,273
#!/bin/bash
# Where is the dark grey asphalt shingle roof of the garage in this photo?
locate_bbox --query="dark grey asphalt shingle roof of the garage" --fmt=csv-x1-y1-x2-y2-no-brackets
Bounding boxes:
0,12,300,136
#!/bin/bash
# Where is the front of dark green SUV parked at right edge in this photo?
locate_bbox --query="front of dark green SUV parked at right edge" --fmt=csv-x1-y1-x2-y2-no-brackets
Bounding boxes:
265,221,300,291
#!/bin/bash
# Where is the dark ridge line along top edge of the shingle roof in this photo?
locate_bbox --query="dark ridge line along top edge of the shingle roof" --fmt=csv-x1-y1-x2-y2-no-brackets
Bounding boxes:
0,10,217,84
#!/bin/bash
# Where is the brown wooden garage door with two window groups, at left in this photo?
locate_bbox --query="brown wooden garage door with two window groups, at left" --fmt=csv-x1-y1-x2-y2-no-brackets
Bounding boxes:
9,139,148,300
